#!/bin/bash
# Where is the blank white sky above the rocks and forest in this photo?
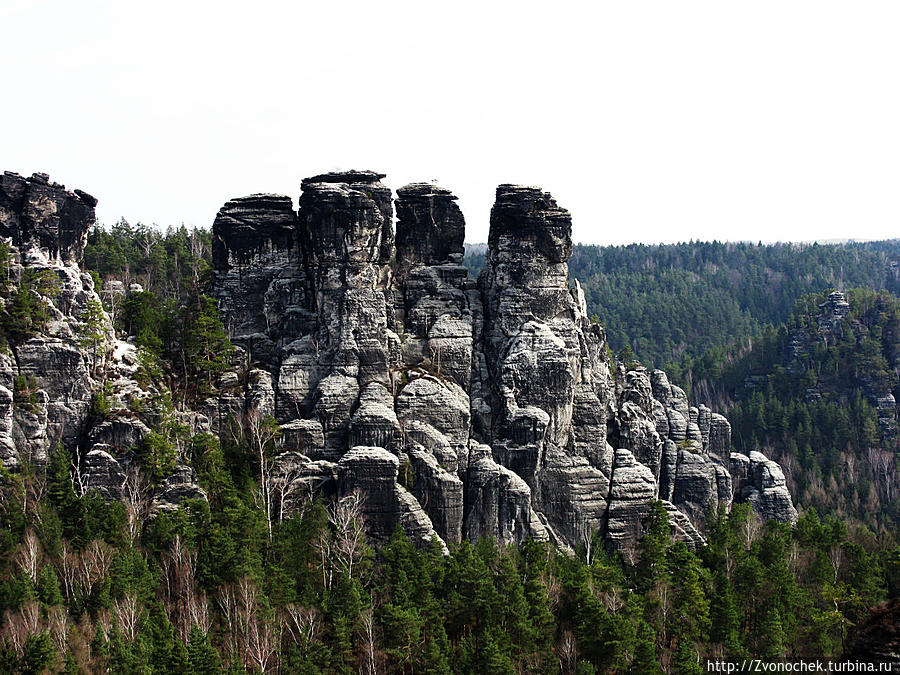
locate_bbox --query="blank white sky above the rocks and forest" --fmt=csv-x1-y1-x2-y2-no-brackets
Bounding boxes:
0,0,900,243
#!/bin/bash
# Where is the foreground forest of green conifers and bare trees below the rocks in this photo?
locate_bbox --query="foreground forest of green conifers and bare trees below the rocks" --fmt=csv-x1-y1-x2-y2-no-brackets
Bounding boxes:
0,464,900,675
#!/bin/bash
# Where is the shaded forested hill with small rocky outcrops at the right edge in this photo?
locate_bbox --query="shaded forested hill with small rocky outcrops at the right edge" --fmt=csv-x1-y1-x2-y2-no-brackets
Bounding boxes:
694,289,900,530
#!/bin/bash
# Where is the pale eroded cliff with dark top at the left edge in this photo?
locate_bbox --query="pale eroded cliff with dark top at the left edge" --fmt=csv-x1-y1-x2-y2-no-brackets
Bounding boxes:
0,172,204,510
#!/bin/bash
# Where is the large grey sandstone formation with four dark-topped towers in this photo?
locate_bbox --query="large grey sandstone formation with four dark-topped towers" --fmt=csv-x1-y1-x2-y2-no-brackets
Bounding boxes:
206,171,796,547
